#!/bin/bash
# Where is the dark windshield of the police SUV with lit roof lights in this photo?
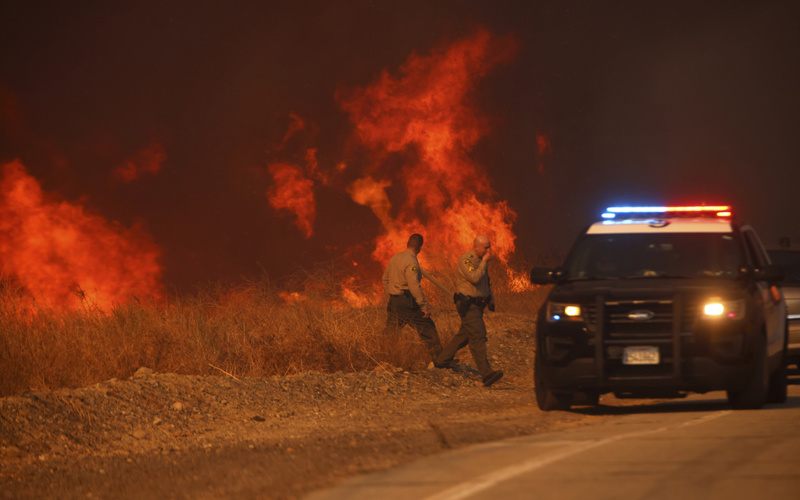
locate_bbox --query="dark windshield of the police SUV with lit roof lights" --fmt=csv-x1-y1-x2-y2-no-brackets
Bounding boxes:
565,233,742,279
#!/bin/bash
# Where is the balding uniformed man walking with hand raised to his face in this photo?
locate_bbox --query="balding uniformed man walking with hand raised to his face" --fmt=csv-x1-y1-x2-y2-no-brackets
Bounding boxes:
434,234,503,387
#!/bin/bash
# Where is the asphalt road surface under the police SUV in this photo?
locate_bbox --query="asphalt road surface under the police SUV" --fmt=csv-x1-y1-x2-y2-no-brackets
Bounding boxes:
307,375,800,500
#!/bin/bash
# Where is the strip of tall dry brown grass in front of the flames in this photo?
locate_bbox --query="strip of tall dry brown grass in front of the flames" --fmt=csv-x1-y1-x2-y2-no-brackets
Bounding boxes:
0,264,542,396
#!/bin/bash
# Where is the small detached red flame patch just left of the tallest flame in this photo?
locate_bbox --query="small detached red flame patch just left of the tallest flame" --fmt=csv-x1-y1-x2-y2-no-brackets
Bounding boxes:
267,163,317,238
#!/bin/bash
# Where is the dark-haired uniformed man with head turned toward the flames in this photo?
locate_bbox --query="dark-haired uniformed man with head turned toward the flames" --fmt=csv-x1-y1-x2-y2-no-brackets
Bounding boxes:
383,233,442,359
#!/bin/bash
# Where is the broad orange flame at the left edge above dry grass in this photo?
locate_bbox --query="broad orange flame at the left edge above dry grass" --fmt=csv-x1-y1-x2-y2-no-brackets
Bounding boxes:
0,160,163,311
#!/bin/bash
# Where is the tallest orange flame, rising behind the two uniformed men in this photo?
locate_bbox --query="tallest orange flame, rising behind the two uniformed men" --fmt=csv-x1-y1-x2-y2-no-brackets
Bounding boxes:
338,30,516,270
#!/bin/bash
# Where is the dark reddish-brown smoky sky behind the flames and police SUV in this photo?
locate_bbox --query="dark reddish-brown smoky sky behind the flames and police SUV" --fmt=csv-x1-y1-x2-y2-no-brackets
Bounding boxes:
0,0,800,287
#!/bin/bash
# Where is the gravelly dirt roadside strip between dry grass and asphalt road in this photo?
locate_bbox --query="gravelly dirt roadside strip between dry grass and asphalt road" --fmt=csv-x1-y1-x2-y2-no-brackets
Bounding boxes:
0,318,600,499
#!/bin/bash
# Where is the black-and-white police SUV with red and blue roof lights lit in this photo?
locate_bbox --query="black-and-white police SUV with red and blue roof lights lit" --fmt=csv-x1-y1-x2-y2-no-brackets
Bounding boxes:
531,206,787,410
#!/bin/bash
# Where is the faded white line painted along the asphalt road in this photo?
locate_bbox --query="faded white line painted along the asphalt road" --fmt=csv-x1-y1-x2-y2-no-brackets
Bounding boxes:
426,410,731,500
